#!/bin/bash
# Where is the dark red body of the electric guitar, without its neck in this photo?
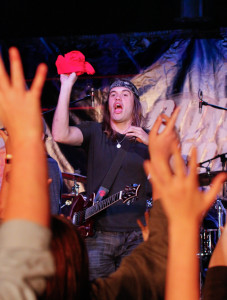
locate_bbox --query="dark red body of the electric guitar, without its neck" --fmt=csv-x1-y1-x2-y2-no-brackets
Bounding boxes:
69,194,94,238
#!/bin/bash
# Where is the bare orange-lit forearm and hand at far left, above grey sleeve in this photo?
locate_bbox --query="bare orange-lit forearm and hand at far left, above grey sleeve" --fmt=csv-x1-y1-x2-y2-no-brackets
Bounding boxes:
0,48,49,226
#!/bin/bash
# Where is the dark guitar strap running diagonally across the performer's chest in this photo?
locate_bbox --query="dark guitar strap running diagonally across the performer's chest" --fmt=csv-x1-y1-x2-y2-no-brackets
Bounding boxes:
94,139,131,203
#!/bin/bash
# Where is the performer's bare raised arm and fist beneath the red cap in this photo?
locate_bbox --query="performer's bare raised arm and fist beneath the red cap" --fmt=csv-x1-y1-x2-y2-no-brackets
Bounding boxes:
52,73,83,146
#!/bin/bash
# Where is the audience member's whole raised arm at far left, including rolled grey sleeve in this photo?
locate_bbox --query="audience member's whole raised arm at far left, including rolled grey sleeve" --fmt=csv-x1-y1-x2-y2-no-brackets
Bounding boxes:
0,48,54,300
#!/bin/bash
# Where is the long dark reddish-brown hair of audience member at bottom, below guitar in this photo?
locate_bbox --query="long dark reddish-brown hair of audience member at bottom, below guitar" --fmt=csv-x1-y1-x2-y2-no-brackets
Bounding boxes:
39,216,90,300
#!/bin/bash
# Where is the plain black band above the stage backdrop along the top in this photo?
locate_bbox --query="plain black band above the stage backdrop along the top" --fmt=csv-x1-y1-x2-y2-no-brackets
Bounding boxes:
0,0,227,38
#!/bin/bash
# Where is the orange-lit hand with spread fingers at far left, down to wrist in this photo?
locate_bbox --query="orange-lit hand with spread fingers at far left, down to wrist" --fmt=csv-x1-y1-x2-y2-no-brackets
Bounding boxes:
0,48,47,142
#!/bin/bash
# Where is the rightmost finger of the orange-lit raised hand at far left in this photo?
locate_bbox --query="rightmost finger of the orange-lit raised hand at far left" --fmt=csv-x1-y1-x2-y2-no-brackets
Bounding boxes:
31,64,47,98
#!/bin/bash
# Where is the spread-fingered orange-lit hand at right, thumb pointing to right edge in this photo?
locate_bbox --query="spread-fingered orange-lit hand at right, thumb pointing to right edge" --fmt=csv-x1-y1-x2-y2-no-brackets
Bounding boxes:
145,145,227,224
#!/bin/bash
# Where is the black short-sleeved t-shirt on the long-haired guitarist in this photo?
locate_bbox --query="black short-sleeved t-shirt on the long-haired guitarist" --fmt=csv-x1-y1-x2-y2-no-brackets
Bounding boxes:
78,122,149,231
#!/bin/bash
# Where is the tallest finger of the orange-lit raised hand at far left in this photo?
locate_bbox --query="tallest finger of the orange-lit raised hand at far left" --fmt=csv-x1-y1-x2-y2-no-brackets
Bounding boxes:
9,47,25,89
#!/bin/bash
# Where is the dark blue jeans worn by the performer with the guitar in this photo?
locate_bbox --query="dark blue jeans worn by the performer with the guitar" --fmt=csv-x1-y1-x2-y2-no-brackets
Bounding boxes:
86,231,143,280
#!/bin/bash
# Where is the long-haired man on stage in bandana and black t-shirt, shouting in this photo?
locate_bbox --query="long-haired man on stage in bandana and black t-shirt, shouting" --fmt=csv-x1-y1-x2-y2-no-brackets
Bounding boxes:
52,73,150,279
